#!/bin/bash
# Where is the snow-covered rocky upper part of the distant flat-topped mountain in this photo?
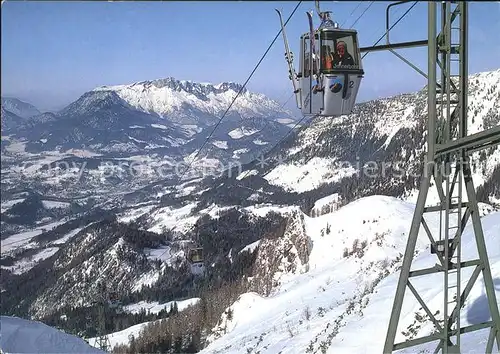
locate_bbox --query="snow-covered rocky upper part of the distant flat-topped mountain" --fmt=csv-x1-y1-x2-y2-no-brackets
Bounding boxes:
94,77,292,126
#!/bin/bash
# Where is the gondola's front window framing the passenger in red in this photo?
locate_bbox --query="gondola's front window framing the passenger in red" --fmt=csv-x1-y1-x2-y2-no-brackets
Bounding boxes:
320,30,361,74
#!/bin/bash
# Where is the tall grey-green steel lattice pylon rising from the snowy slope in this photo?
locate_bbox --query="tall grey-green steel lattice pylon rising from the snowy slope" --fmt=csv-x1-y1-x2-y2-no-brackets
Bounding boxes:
384,1,500,353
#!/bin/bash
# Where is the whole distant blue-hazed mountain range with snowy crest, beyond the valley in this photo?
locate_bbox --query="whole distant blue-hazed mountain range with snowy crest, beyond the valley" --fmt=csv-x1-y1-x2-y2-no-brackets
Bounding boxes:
2,78,294,156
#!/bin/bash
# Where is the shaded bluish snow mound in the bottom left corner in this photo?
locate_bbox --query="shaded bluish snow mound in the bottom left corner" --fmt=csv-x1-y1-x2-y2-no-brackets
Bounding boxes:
0,316,104,354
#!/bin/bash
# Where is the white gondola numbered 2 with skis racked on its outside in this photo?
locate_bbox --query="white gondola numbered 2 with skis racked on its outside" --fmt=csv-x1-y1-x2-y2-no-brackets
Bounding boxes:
276,0,364,116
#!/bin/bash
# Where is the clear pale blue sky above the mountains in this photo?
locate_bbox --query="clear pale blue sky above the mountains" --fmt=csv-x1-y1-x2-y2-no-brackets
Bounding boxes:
1,1,500,109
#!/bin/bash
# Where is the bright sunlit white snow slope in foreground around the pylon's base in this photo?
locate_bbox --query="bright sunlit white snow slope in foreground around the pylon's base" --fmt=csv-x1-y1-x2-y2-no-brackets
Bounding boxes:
202,196,500,354
